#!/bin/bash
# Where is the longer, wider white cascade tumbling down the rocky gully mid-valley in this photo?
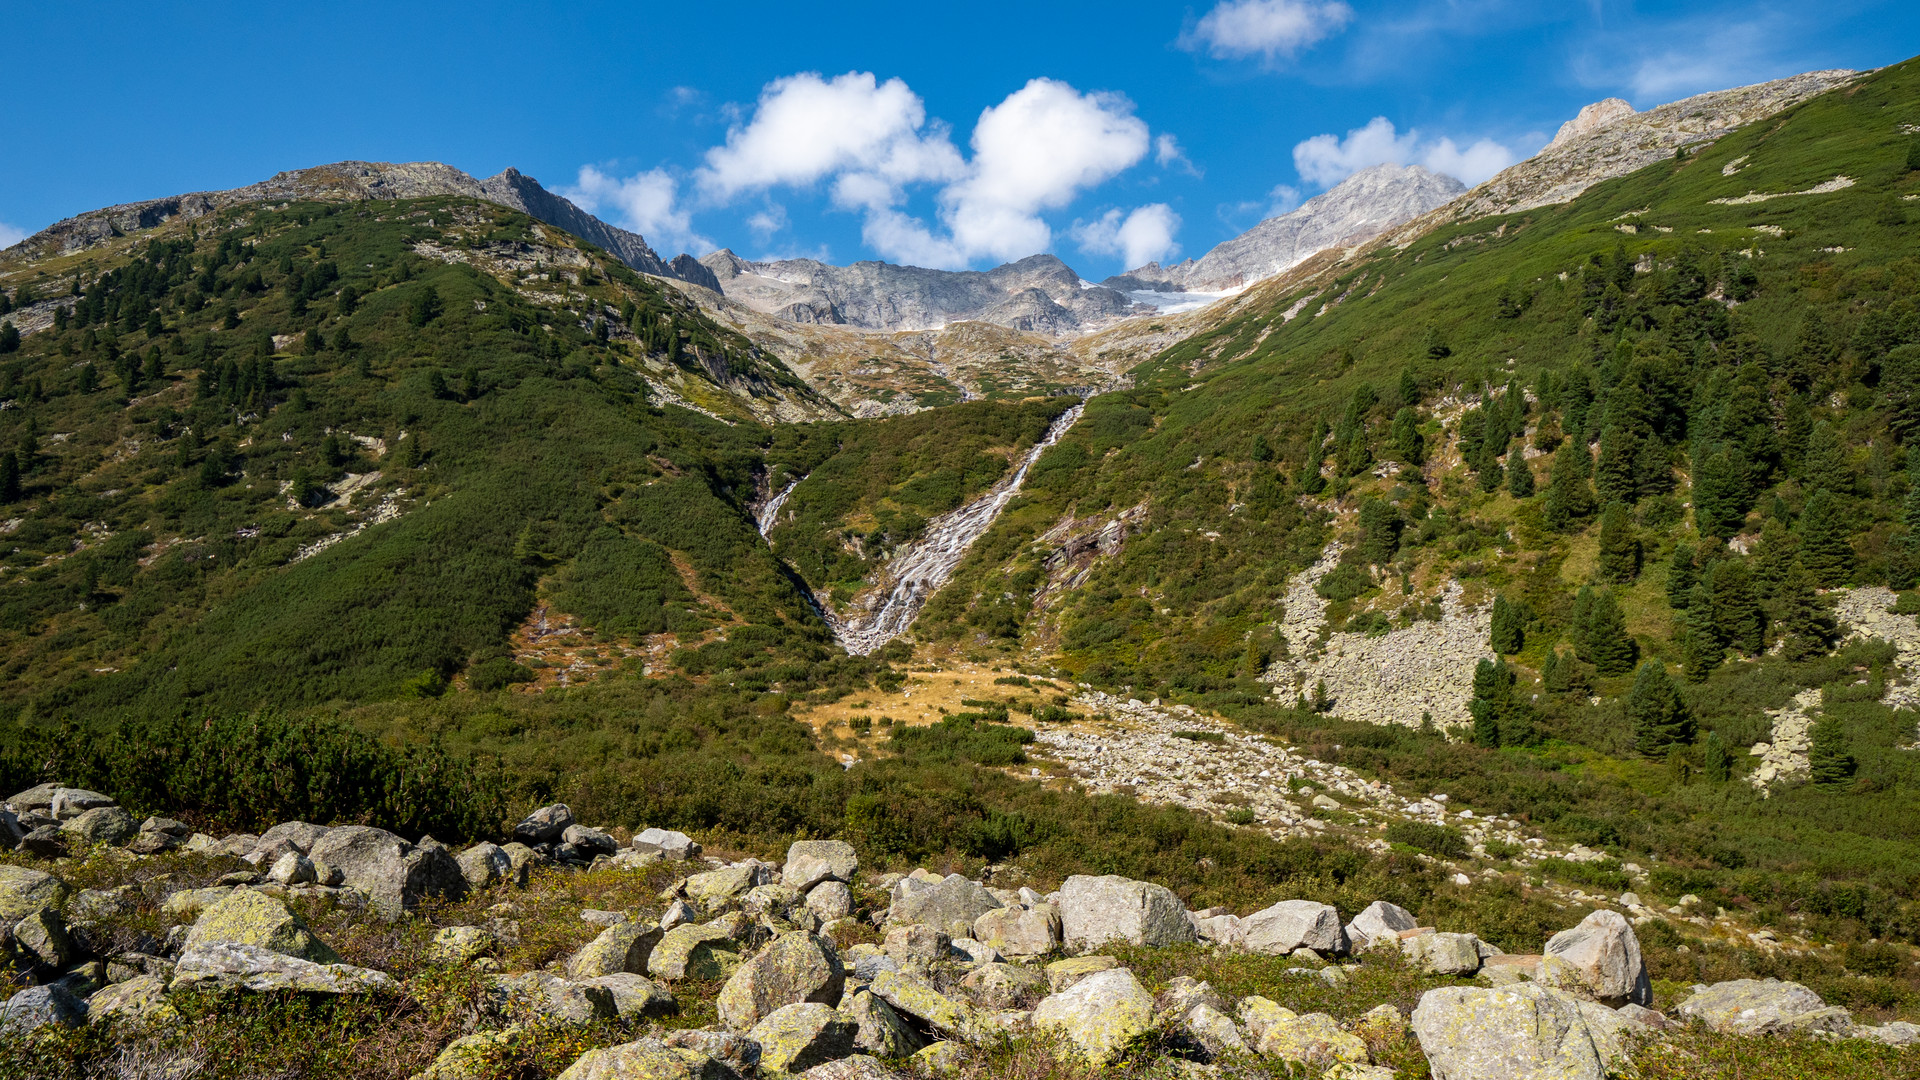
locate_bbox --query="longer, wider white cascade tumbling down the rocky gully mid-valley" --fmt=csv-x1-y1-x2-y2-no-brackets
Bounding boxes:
829,405,1087,655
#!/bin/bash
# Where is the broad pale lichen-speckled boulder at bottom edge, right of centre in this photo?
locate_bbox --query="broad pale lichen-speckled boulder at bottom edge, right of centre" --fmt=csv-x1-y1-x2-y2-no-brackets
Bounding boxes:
1413,982,1613,1080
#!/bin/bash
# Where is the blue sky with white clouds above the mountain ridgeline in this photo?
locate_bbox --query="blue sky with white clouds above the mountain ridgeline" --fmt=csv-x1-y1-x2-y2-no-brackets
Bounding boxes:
0,0,1920,277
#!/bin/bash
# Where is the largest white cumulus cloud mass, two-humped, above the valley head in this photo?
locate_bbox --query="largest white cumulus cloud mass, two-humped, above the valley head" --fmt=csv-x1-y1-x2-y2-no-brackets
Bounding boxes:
695,71,1159,267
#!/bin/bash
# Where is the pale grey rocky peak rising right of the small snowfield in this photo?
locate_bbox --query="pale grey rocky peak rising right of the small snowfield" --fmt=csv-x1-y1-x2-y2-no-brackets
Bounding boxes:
1102,163,1467,292
